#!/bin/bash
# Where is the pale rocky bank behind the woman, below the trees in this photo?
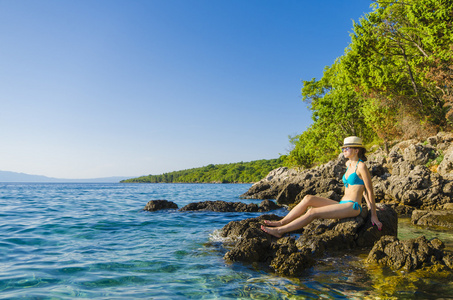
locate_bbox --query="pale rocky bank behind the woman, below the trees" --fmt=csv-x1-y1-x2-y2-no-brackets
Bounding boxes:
241,133,453,219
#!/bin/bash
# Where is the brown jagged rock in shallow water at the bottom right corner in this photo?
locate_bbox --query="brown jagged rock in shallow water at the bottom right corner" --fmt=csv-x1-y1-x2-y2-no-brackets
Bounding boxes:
366,236,451,271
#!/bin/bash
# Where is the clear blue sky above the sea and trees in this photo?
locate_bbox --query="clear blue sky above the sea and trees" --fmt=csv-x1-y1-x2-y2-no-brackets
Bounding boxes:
0,0,371,178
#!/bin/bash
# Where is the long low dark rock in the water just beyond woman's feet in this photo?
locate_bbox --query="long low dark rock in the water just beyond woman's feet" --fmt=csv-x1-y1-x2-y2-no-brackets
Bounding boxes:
180,200,281,212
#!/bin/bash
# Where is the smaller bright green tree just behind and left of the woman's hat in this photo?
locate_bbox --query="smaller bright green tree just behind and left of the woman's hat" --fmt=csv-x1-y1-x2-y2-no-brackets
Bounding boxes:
287,59,374,167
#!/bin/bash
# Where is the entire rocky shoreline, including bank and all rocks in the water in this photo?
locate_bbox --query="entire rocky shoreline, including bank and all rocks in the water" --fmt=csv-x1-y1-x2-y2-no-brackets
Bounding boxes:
145,133,453,276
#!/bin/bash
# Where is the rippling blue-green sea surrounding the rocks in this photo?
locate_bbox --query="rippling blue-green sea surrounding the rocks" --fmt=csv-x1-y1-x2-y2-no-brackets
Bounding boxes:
0,183,453,299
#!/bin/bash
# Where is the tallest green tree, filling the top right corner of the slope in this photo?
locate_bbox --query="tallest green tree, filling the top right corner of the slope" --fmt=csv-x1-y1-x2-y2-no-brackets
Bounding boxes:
344,0,453,134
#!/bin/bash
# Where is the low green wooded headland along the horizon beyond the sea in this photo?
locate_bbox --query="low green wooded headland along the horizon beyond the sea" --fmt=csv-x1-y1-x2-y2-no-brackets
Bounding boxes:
121,158,283,183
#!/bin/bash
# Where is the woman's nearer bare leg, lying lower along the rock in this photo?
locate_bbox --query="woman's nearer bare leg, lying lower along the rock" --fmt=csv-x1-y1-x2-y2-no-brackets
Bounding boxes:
261,200,360,238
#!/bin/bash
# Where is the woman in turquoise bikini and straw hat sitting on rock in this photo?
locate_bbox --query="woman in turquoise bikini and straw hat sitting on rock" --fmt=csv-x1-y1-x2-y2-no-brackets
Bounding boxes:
261,136,382,238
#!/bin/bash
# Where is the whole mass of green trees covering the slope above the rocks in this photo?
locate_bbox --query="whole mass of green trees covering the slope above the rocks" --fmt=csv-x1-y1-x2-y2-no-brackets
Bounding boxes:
285,0,453,168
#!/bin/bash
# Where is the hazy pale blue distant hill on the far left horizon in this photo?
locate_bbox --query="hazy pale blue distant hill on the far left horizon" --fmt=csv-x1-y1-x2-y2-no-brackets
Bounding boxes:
0,171,128,183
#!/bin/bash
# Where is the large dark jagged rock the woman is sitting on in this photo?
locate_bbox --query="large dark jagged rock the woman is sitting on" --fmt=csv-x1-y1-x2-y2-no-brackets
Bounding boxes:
220,204,398,276
